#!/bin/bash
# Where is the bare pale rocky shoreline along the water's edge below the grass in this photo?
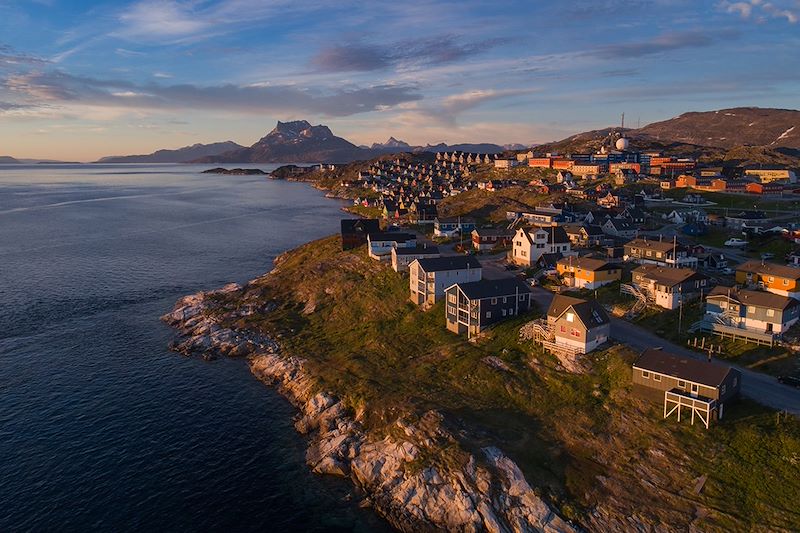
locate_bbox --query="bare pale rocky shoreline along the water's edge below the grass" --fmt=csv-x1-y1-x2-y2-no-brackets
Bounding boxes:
162,284,576,533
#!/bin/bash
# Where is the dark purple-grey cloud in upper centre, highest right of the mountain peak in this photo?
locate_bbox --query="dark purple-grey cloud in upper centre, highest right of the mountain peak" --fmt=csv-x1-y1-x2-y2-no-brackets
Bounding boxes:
310,35,505,72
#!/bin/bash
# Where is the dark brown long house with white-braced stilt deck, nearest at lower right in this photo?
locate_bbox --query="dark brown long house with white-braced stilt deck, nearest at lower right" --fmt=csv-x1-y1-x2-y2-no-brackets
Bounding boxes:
632,348,742,428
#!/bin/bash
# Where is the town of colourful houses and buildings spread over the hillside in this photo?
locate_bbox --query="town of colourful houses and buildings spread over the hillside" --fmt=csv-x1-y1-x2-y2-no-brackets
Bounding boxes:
341,133,800,428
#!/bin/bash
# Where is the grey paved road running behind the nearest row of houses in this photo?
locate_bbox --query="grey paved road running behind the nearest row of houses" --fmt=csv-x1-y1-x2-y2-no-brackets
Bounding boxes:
533,287,800,416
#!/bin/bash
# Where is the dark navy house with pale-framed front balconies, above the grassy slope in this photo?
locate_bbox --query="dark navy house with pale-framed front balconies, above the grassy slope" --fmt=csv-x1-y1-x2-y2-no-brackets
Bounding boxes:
445,278,532,337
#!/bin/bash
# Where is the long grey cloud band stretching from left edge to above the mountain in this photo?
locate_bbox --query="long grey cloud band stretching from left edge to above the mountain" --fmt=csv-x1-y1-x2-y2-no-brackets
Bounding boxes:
5,71,422,116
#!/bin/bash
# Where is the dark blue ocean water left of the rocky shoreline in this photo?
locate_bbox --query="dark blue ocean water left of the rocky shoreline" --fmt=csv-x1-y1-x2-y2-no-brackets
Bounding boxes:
0,165,388,531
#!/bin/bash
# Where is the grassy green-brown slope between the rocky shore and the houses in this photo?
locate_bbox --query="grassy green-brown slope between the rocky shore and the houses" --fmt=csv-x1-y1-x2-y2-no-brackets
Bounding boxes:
209,238,800,530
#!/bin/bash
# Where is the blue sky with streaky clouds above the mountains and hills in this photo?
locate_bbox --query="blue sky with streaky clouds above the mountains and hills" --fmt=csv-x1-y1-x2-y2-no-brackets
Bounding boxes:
0,0,800,161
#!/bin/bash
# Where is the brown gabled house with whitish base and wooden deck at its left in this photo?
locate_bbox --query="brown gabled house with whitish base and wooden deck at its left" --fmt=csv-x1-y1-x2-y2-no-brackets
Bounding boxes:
547,294,611,353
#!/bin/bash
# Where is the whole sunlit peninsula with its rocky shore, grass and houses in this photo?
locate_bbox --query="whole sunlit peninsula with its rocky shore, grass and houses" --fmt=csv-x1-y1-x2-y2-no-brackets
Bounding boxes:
164,114,800,531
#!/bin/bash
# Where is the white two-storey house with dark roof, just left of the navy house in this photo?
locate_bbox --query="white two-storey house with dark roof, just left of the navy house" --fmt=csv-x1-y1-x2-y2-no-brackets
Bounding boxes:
408,255,482,305
